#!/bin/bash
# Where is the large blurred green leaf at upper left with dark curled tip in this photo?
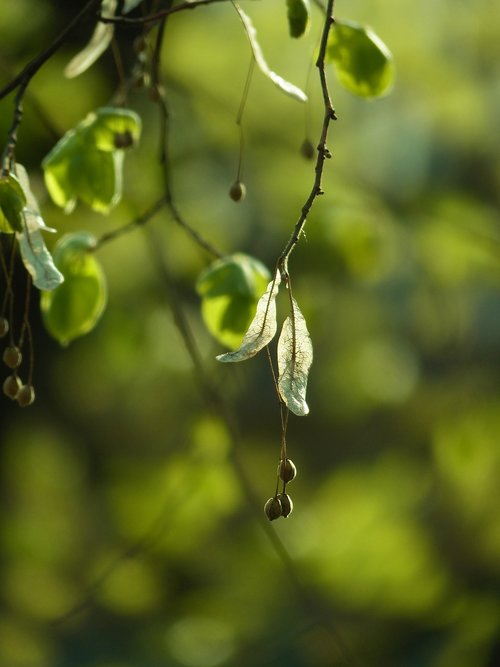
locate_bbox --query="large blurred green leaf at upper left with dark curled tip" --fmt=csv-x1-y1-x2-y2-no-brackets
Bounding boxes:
42,107,141,213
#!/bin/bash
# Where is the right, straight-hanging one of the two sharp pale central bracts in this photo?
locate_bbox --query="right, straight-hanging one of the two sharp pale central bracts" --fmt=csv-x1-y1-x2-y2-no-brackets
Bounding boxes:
278,298,313,417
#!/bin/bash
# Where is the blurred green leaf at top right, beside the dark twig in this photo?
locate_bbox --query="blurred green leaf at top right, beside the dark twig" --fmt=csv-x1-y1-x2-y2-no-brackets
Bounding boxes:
326,21,394,98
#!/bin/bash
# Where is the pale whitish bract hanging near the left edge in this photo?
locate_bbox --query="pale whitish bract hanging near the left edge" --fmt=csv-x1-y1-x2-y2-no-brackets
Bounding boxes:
16,164,64,291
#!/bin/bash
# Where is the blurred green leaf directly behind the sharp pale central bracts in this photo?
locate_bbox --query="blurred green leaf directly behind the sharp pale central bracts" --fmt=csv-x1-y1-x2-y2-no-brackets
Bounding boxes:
196,253,270,349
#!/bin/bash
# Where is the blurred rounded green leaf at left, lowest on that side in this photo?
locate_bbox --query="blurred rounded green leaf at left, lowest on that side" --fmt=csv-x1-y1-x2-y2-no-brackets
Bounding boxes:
40,233,107,345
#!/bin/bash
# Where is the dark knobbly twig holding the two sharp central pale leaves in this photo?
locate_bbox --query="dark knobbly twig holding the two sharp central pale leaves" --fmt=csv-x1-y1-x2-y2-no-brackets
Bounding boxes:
277,0,337,282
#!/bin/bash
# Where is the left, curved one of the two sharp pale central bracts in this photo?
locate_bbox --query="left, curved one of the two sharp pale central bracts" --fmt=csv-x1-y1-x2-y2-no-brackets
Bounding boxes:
217,271,281,362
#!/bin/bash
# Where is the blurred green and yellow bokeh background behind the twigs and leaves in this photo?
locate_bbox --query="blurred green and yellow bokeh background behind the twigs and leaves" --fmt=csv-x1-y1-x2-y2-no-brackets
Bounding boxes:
0,0,500,667
